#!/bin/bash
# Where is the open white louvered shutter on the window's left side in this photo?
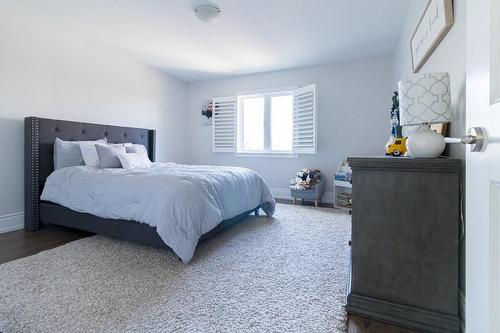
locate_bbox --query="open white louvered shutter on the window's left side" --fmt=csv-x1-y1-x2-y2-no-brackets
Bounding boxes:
212,96,236,152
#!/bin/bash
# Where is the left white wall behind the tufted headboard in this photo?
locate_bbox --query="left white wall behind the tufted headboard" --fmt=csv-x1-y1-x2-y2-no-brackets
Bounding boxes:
0,14,187,231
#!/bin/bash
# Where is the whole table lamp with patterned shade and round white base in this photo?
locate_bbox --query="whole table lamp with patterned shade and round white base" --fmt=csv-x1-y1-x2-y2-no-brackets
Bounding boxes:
399,73,452,157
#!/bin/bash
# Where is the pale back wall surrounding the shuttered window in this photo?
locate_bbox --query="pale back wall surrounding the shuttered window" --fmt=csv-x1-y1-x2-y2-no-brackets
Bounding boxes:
186,56,394,201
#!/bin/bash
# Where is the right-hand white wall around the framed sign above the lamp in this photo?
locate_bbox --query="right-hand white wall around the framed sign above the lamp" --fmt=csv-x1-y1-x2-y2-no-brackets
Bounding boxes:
394,0,466,159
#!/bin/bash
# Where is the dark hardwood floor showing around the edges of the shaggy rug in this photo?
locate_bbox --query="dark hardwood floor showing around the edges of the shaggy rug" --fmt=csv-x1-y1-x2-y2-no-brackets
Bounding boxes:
0,206,415,333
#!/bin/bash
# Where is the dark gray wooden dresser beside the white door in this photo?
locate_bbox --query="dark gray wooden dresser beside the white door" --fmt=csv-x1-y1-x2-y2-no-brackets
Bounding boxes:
347,157,462,332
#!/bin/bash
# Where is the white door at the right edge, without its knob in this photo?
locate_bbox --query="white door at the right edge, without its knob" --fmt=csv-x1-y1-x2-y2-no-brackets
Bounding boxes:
465,0,500,333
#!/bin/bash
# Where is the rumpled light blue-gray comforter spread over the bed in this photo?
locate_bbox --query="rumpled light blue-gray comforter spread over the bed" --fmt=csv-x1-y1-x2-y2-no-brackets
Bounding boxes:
41,163,276,263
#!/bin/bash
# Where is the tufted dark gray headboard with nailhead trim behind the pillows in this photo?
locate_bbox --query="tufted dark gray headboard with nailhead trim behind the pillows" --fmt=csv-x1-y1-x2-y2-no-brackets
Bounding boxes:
24,117,156,230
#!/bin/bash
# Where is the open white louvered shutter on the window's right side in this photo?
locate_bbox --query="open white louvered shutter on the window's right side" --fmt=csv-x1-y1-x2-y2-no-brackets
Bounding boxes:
293,84,316,154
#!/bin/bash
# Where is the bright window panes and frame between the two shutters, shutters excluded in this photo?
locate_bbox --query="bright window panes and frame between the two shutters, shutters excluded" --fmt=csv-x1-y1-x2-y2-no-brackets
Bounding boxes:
236,91,293,153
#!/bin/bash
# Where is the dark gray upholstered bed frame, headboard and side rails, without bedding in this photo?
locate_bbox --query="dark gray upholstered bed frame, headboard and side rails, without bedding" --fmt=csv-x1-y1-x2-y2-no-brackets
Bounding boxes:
24,117,260,247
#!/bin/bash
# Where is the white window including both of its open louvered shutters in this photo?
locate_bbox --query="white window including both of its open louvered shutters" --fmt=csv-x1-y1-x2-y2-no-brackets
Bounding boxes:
212,84,316,156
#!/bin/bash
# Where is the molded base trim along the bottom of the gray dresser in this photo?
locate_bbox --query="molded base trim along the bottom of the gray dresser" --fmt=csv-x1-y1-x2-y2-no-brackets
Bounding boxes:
346,293,460,333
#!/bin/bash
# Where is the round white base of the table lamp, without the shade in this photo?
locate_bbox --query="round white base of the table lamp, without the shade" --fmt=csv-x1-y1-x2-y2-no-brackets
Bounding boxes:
406,125,446,157
